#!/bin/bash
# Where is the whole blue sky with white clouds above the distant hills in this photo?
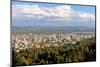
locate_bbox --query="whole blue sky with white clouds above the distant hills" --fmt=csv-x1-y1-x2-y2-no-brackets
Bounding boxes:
12,1,95,27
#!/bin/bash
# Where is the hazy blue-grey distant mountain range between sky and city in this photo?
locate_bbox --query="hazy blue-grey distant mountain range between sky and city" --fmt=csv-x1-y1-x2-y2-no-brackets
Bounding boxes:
12,26,95,32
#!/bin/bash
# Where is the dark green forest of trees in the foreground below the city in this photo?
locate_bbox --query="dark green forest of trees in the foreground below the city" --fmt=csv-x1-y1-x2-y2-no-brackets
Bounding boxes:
12,38,96,66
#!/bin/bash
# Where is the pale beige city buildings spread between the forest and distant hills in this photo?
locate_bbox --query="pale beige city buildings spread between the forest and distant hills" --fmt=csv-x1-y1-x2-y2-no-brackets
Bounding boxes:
11,33,95,52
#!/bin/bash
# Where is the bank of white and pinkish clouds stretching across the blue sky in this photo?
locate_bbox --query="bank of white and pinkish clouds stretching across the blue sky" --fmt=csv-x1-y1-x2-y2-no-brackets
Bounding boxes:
12,4,95,22
